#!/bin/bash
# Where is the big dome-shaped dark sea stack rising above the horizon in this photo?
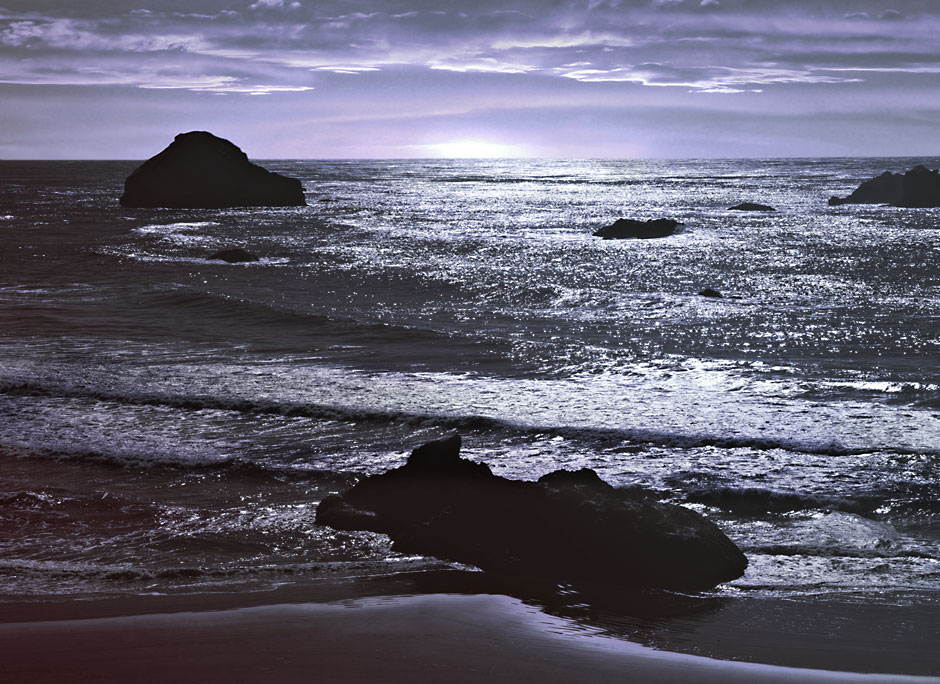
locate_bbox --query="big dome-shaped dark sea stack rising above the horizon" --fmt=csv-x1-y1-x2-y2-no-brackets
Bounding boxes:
121,131,307,209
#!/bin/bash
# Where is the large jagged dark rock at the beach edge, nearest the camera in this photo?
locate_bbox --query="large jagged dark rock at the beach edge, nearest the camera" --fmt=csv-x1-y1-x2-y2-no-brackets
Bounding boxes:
317,435,747,591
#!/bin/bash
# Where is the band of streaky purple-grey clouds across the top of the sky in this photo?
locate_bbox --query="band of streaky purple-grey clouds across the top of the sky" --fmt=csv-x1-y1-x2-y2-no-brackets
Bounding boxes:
0,0,940,93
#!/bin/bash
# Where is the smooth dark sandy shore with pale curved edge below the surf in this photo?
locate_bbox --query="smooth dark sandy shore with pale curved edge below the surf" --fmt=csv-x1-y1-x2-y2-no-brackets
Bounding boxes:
0,590,940,684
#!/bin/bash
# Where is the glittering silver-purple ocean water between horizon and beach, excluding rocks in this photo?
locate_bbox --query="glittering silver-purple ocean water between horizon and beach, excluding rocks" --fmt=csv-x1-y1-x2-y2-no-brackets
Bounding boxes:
0,159,940,609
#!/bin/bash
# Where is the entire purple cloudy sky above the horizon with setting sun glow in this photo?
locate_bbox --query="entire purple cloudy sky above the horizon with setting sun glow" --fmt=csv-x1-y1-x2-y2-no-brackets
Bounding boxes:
0,0,940,159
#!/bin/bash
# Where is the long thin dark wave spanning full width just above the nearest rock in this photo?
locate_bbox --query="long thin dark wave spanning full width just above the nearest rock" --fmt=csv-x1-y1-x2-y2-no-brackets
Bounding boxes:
0,382,940,462
